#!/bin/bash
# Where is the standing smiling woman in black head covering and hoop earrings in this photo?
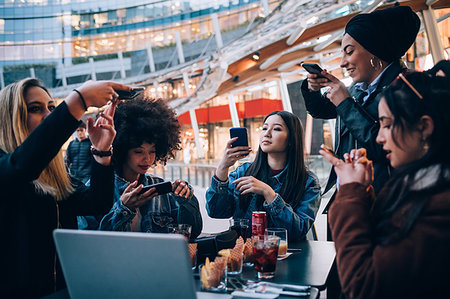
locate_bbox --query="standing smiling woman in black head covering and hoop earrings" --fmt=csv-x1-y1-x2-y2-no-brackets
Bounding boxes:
302,6,420,203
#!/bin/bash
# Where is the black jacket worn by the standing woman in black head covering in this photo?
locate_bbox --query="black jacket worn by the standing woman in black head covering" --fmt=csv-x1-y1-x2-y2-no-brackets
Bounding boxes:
301,61,406,193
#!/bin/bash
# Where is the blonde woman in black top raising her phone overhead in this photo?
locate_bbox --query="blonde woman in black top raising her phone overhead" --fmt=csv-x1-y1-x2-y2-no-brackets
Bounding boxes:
0,78,130,298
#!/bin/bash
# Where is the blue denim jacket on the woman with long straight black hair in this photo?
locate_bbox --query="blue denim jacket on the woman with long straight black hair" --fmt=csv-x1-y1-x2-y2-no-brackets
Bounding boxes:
206,163,321,240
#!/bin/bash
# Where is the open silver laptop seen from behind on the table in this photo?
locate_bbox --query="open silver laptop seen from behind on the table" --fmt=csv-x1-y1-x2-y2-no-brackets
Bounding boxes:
53,229,196,299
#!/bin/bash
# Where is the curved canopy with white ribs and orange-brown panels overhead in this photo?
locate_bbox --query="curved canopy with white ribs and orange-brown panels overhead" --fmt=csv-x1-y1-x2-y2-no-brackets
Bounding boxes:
165,0,450,114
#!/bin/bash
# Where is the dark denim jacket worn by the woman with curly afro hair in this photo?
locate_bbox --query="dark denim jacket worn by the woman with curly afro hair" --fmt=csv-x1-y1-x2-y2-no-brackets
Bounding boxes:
89,174,203,238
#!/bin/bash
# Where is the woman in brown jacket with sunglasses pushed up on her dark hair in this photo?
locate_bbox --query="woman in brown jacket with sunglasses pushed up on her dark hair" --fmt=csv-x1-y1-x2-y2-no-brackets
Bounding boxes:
321,73,450,298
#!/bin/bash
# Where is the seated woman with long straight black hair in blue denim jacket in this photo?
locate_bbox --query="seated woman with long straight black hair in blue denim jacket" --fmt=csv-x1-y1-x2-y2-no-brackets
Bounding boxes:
206,111,321,240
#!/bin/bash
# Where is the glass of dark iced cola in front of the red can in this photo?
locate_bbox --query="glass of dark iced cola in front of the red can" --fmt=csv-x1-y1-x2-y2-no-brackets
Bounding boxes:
252,235,280,279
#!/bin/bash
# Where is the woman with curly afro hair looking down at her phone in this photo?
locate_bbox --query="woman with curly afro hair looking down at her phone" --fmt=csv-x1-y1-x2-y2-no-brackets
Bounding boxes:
80,98,202,238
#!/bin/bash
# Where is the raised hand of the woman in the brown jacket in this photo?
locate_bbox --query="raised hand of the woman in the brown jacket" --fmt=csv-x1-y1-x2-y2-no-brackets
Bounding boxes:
319,145,373,188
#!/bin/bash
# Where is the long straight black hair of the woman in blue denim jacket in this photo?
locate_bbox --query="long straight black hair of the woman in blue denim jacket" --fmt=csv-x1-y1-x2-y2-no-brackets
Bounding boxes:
239,111,307,211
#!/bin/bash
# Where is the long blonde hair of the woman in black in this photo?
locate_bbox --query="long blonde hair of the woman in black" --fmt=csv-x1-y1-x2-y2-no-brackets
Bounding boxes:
0,78,74,200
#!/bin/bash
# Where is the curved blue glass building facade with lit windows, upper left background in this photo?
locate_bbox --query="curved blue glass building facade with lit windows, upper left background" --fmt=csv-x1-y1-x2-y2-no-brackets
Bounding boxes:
0,0,272,65
